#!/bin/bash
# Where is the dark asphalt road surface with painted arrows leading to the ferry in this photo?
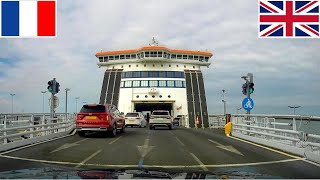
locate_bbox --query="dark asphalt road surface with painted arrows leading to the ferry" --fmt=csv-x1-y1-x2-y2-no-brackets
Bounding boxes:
0,128,320,178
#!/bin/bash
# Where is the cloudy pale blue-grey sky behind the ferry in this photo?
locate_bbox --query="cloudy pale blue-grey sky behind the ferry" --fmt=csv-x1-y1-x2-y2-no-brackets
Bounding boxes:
0,0,320,115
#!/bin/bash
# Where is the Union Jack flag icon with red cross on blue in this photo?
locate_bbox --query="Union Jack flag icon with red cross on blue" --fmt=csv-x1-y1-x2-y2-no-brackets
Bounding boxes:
259,0,320,38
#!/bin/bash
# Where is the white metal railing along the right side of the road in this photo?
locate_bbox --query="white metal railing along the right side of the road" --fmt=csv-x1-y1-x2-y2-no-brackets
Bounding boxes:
231,114,320,163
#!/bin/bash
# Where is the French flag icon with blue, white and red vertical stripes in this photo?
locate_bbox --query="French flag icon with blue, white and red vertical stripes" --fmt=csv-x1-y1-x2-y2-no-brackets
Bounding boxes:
0,0,57,38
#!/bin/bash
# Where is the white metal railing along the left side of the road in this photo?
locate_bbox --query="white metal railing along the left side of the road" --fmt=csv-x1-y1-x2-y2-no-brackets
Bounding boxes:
0,113,75,151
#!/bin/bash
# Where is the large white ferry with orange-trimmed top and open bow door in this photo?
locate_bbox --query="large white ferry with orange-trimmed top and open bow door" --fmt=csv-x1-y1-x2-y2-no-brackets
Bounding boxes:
96,39,213,128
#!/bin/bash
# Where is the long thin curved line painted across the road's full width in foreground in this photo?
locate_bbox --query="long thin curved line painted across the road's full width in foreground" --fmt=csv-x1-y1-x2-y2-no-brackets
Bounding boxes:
0,153,305,169
